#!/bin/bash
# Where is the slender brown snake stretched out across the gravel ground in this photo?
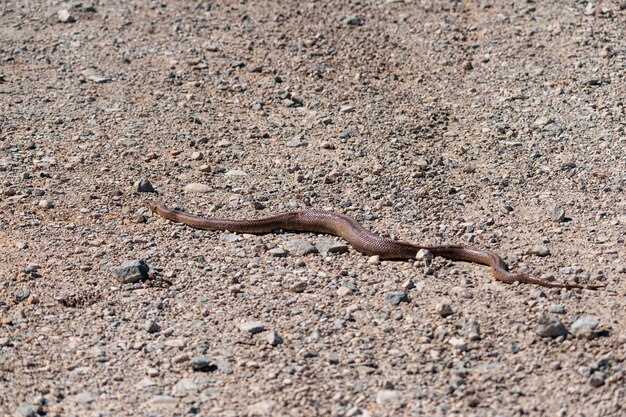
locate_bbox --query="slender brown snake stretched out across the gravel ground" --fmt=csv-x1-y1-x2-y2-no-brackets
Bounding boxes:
145,200,599,289
